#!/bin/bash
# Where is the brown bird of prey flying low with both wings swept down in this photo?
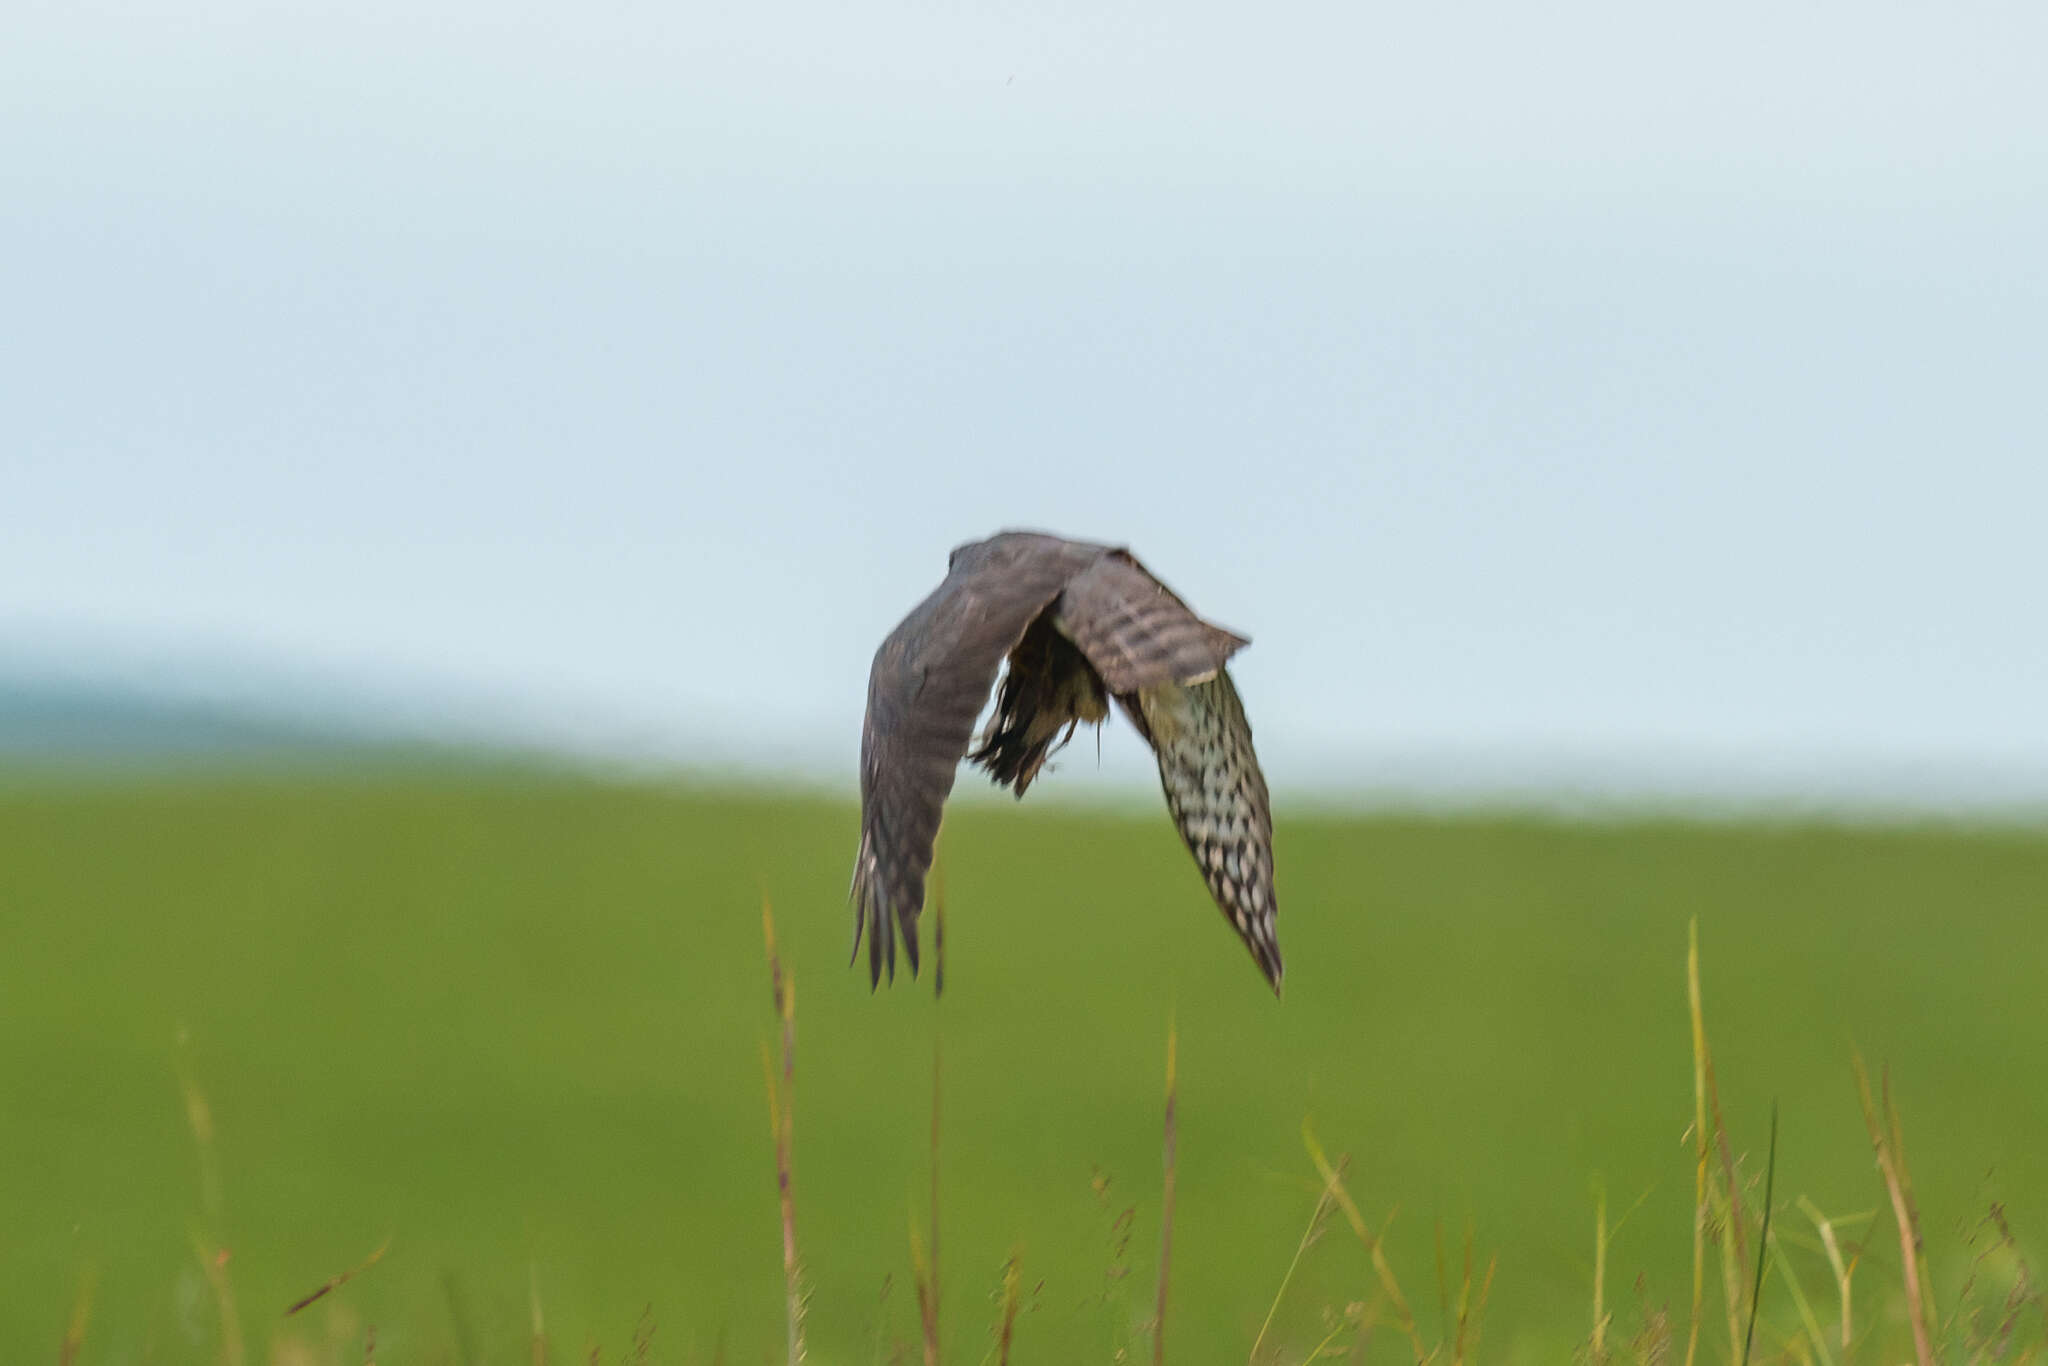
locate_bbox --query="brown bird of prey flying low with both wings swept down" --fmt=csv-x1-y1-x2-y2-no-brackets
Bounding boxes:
852,530,1280,993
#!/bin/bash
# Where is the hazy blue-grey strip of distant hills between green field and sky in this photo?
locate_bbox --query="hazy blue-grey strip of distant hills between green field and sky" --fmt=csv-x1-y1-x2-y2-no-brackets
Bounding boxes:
0,655,2048,827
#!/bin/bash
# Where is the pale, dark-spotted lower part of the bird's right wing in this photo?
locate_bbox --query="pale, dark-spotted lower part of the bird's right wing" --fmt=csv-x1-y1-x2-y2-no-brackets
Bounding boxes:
1118,668,1282,995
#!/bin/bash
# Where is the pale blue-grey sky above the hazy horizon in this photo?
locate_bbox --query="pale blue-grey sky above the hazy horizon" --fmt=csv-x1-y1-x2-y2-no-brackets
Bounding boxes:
0,0,2048,793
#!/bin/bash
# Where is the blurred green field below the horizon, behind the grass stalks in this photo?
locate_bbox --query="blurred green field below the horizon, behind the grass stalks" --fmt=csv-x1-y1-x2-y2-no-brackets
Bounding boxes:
0,774,2048,1364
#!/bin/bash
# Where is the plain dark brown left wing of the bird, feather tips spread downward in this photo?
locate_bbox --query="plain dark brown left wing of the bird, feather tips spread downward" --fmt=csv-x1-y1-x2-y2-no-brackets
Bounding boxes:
852,532,1106,983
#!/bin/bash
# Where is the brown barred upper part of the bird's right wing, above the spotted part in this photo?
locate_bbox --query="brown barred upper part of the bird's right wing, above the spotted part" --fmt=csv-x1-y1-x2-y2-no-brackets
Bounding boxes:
1055,551,1251,694
